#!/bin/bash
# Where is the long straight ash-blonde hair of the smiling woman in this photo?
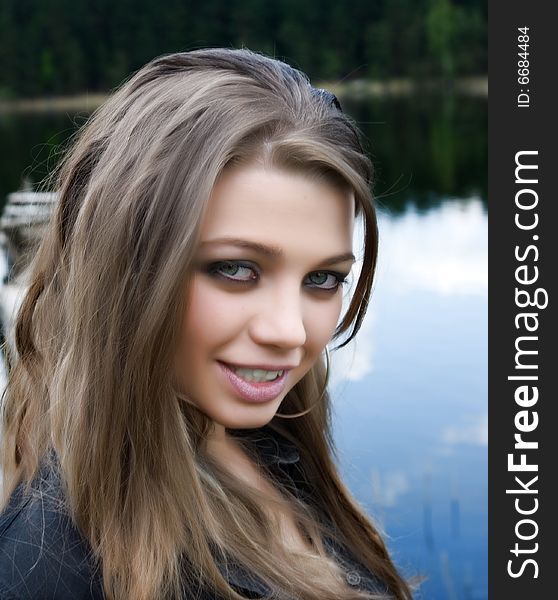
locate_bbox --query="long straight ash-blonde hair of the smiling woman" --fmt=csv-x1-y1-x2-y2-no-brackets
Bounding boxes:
1,49,411,600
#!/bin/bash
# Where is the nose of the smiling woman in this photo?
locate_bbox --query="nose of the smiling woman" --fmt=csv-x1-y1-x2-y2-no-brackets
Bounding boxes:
251,288,306,348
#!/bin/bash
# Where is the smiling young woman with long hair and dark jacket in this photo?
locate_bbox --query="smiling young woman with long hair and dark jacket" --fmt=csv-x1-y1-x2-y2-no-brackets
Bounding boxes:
0,49,411,600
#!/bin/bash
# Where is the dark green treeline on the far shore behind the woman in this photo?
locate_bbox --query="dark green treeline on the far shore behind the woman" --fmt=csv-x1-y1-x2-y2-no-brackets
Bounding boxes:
0,0,487,98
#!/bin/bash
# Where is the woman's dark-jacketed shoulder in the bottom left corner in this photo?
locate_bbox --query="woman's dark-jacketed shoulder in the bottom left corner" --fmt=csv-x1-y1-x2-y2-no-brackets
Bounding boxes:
0,458,104,600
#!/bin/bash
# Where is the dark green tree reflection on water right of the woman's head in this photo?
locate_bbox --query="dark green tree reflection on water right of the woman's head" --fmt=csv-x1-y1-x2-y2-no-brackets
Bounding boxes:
343,95,488,213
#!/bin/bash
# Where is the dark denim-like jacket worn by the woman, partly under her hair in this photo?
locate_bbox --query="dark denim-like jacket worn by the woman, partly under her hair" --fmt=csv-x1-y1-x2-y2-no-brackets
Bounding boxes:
0,426,392,600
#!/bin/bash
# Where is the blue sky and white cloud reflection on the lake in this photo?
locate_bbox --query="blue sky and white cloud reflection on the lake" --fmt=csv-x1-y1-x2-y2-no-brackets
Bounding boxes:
332,196,488,600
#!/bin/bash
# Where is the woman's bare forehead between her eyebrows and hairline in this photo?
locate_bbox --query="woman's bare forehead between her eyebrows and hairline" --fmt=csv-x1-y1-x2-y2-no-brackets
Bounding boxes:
201,166,354,253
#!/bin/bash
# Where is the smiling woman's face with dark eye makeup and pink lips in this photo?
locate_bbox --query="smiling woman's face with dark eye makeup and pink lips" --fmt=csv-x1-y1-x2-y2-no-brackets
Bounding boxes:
176,166,354,429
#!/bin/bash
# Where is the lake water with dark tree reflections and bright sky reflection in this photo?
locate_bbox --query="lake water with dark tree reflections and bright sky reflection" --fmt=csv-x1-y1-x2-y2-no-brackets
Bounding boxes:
0,91,488,600
